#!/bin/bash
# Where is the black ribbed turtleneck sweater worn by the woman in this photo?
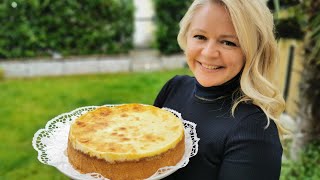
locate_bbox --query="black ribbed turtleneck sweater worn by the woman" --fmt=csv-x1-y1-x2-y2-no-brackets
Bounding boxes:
154,76,282,180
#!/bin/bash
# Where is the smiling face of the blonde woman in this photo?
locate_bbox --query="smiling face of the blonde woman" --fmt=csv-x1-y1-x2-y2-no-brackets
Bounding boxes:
185,3,245,87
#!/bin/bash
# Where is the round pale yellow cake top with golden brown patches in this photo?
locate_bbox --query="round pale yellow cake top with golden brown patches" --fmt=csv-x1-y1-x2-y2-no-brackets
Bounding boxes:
69,104,184,162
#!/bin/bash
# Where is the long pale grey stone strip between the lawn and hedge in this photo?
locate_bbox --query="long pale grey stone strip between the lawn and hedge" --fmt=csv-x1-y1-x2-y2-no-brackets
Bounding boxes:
0,50,185,78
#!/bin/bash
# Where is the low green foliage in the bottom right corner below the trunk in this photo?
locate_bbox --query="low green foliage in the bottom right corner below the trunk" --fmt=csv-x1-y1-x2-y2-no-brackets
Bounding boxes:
280,141,320,180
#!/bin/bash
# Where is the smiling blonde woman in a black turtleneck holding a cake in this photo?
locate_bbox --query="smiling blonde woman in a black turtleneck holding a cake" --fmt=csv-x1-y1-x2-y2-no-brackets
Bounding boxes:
154,0,285,180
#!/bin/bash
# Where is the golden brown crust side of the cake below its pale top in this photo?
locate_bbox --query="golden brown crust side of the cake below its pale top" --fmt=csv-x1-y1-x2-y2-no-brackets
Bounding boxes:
67,137,185,180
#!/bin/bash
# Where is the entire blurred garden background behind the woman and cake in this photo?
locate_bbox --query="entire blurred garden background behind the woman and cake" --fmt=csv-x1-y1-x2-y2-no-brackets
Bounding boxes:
0,0,320,180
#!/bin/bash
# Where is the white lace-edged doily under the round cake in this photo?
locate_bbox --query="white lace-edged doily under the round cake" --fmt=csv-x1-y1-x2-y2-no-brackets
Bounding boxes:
32,105,200,180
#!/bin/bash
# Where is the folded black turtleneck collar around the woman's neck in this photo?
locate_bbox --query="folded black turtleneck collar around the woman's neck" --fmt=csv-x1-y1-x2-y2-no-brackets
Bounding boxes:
194,73,241,102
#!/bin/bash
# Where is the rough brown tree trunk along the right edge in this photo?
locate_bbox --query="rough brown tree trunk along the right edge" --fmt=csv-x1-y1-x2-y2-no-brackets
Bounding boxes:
291,0,320,160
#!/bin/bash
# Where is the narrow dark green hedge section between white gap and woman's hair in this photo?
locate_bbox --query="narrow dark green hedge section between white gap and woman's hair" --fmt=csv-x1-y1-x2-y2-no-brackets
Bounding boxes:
153,0,192,54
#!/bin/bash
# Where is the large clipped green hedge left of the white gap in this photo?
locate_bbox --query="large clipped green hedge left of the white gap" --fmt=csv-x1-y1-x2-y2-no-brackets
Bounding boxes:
0,0,134,59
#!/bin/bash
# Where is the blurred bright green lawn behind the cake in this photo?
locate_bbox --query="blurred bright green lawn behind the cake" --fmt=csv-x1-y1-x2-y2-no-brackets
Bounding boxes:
0,69,190,180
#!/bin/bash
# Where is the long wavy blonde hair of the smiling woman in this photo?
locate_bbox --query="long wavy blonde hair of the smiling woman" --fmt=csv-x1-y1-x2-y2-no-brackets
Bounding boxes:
178,0,287,135
